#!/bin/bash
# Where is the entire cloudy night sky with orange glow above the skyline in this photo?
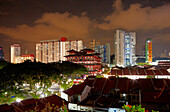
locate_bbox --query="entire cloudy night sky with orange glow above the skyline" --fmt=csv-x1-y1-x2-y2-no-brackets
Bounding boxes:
0,0,170,60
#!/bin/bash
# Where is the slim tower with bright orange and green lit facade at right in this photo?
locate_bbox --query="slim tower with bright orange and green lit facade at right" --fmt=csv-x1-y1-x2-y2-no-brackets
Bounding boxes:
145,38,152,63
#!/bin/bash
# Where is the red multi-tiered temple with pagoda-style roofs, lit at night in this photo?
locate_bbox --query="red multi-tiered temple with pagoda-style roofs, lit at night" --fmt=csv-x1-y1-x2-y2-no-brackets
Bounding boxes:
65,49,101,75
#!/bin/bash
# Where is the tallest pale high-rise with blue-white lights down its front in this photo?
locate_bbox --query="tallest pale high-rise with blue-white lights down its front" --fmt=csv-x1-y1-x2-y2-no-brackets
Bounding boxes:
115,30,136,67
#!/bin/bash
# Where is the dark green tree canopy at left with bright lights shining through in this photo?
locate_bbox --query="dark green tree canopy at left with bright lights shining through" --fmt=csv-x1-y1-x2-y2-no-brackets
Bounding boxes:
0,61,87,103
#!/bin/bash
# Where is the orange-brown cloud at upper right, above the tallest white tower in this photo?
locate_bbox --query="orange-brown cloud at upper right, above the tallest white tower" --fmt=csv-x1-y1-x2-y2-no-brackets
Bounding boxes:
98,0,170,31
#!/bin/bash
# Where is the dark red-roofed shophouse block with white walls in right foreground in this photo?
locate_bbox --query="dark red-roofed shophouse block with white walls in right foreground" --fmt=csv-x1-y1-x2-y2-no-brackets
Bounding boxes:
61,76,170,112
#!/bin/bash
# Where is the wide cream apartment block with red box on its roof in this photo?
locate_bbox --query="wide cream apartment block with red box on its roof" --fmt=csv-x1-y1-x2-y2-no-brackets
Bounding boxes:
36,37,83,63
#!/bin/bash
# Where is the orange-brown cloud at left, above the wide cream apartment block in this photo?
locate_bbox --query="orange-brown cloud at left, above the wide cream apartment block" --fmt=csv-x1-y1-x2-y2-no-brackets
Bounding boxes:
0,12,91,42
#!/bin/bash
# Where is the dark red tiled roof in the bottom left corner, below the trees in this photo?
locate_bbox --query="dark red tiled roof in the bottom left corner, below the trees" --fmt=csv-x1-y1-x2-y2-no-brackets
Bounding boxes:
0,95,68,112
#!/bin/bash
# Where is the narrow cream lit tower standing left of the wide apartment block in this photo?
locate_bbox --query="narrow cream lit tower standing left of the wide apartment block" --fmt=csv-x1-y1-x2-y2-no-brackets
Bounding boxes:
11,44,21,63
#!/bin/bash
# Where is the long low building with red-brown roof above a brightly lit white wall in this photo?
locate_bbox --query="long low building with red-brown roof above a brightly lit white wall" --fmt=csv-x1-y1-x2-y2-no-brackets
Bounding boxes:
105,65,170,79
